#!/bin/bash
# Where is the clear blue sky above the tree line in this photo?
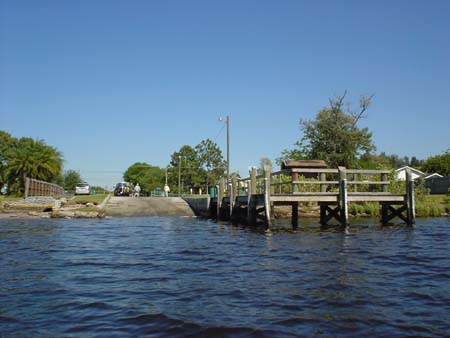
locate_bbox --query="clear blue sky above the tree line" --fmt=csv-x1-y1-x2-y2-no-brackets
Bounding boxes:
0,0,450,186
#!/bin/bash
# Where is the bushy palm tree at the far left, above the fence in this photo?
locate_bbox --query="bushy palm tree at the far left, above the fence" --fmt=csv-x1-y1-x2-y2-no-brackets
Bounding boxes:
7,137,63,192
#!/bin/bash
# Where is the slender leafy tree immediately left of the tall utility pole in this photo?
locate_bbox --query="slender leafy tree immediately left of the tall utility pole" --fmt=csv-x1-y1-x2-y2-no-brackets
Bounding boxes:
195,139,226,192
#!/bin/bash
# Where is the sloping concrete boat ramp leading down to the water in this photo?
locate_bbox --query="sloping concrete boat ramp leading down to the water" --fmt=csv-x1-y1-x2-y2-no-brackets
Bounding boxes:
105,197,195,216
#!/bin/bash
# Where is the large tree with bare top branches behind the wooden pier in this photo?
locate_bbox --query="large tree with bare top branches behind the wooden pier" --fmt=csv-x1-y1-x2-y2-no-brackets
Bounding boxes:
279,92,375,167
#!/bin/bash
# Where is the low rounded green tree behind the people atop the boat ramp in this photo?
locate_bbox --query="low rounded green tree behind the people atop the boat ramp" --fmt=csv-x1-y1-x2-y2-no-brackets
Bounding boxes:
123,162,165,194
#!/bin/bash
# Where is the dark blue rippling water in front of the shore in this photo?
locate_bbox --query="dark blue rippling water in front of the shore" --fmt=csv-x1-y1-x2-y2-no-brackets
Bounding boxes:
0,217,450,337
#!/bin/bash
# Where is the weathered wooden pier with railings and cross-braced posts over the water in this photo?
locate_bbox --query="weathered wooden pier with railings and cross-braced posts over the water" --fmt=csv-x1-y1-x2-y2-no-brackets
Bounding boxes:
210,162,415,229
